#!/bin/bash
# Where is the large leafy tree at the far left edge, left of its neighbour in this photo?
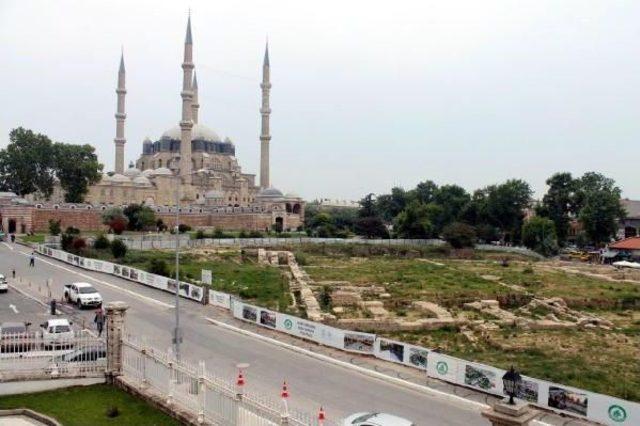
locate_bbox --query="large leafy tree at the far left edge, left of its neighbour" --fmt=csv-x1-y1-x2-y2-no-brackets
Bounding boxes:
0,127,54,198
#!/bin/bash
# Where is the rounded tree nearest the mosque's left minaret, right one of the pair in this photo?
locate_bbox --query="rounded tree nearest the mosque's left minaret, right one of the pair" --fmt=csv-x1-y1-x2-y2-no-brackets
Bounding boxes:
53,143,102,203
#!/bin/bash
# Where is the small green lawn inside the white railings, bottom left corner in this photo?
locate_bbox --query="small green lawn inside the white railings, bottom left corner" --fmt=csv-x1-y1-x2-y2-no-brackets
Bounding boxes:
0,385,180,426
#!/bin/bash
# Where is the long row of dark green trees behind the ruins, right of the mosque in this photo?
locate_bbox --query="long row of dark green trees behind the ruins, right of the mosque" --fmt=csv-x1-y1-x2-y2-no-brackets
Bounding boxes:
305,172,625,254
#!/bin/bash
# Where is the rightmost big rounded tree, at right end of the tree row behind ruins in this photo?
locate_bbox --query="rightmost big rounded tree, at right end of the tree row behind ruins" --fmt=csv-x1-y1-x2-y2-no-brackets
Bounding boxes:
576,172,625,246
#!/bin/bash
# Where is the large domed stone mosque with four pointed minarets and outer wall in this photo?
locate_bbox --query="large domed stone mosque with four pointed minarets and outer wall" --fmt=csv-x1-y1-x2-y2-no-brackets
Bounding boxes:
0,17,304,232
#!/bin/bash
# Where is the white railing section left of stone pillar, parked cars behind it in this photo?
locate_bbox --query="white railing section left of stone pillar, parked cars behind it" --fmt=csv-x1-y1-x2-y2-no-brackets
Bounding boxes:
0,332,106,382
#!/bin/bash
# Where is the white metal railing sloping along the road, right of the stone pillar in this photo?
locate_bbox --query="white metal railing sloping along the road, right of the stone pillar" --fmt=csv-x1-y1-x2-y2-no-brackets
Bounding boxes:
123,336,339,426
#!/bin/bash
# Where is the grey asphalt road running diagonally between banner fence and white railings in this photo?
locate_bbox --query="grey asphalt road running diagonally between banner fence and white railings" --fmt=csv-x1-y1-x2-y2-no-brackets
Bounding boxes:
0,243,488,426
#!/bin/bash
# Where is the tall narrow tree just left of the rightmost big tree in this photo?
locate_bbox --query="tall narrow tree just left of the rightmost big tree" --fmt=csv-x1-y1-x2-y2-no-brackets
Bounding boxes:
536,172,579,245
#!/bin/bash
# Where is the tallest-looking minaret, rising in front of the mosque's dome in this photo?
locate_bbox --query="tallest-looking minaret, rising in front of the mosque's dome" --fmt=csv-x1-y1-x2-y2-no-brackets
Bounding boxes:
180,15,193,185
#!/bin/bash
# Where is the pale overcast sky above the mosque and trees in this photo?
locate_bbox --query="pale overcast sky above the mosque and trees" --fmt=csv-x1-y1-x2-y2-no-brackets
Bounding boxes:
0,0,640,200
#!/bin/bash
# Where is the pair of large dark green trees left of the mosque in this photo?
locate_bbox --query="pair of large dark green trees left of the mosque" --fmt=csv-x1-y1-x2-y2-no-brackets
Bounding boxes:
0,127,102,203
